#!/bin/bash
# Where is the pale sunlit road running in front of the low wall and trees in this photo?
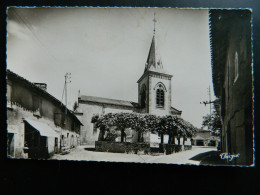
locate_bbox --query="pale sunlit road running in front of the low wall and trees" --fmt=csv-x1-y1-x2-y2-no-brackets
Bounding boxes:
52,146,216,165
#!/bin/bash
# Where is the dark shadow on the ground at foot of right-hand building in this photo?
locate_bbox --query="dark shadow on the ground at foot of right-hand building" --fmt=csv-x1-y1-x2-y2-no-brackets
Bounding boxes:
189,151,228,165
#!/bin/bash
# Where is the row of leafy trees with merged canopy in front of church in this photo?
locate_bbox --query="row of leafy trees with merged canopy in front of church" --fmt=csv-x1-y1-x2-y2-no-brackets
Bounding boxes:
91,112,197,145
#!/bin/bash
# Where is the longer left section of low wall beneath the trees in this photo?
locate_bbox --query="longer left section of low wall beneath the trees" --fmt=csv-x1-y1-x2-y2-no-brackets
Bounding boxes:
95,141,150,154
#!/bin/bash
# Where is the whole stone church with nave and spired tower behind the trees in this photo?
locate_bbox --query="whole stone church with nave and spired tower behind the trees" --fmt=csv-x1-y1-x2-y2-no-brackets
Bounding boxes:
75,19,182,145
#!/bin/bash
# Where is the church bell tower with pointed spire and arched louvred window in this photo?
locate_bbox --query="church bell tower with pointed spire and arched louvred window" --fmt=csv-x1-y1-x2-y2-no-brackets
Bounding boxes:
137,14,172,115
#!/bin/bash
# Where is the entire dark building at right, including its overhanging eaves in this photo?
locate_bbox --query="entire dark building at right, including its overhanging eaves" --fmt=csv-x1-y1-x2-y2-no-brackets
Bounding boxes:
210,10,253,165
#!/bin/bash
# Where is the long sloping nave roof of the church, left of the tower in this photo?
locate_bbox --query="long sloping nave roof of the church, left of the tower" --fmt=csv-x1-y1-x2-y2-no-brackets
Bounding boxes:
79,95,138,108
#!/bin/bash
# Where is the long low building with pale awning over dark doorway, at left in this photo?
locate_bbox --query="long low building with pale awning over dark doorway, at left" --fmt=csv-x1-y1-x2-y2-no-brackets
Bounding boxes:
6,70,82,158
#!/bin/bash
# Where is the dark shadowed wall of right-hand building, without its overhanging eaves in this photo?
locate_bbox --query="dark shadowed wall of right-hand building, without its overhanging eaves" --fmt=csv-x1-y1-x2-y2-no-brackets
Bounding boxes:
221,12,253,165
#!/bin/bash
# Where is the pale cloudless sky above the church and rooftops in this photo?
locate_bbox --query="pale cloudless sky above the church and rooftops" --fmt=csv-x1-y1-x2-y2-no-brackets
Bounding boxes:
7,7,215,128
